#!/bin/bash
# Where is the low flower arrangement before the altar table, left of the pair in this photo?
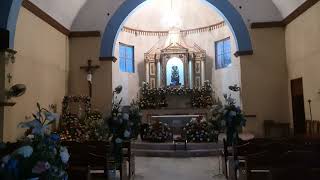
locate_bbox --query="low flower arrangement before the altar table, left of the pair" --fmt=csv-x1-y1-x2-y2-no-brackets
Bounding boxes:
144,120,172,143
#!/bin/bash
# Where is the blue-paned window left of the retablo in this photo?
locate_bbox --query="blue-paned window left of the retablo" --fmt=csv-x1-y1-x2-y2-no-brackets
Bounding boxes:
119,43,134,73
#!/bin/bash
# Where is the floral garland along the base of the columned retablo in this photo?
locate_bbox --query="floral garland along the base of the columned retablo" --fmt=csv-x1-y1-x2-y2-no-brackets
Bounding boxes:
139,81,214,109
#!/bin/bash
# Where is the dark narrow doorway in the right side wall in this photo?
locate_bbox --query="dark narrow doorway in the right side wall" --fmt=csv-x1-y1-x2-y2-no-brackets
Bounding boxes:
291,78,306,135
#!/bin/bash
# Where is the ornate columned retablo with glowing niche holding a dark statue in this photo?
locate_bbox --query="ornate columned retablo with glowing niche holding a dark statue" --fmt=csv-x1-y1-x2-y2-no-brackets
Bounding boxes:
144,29,206,89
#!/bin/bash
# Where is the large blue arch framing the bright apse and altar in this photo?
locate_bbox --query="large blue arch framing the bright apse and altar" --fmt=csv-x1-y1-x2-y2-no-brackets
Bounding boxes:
100,0,252,60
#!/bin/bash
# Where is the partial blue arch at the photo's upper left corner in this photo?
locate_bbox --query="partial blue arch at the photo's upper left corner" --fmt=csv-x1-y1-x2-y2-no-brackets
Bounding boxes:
0,0,22,49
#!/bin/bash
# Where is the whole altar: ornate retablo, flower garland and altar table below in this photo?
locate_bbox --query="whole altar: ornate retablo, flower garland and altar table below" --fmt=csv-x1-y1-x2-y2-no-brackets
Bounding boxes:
140,28,214,125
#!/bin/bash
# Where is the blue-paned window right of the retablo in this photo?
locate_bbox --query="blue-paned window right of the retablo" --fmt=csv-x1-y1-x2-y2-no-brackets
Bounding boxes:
215,38,231,69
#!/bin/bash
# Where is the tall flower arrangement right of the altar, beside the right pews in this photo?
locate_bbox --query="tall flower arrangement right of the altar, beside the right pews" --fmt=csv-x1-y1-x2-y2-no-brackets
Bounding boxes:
222,94,246,145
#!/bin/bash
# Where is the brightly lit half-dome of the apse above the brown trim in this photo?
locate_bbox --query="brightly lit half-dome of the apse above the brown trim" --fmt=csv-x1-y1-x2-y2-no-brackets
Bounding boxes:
124,0,223,31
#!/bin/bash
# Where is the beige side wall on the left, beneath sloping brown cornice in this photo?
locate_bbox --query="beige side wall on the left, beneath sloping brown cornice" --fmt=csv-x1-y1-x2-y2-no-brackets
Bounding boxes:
4,8,69,141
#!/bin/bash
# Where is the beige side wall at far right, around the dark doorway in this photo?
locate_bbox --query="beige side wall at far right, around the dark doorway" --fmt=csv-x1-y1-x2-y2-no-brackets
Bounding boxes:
285,2,320,120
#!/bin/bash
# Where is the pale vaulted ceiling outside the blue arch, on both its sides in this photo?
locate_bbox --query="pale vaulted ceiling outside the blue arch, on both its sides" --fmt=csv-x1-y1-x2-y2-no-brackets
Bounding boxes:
30,0,306,31
